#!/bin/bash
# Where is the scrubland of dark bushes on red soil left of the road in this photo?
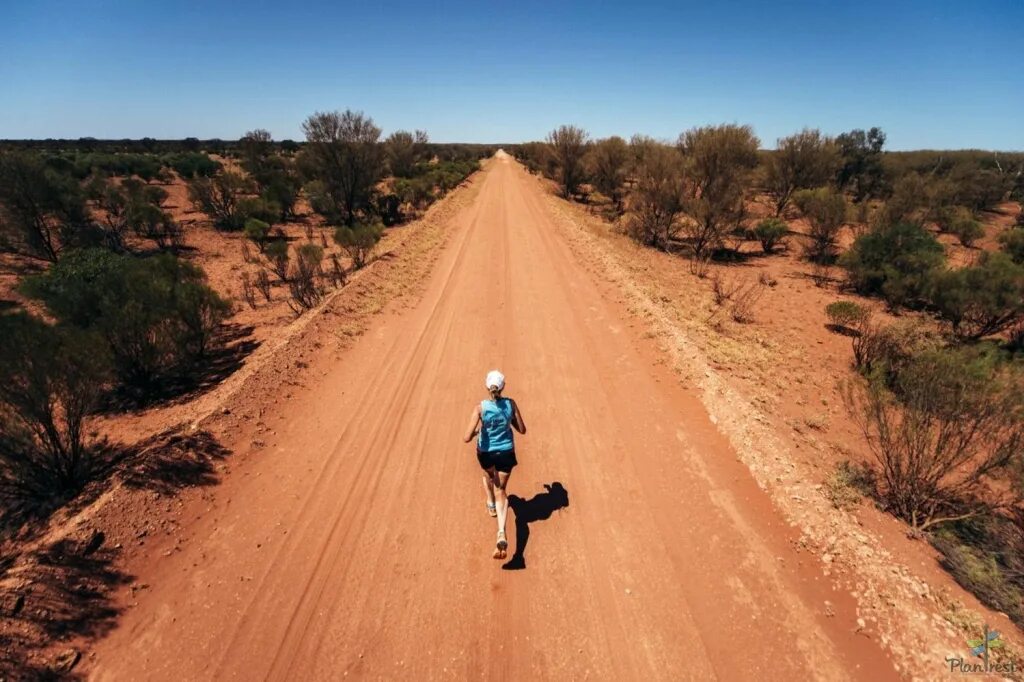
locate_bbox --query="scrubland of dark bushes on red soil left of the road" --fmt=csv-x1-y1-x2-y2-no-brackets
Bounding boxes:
0,116,494,531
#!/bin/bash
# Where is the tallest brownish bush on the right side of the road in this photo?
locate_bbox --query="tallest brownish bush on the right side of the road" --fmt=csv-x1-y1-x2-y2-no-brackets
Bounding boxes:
677,124,760,260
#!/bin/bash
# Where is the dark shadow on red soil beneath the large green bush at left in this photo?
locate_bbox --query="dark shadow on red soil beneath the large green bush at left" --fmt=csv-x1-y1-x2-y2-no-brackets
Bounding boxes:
97,324,259,414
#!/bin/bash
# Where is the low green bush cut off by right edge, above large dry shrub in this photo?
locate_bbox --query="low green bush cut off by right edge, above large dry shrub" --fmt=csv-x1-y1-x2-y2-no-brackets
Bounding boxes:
929,252,1024,340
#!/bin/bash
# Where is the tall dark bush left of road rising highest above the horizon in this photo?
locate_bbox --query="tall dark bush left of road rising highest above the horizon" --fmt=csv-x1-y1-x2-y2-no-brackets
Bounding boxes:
302,110,384,227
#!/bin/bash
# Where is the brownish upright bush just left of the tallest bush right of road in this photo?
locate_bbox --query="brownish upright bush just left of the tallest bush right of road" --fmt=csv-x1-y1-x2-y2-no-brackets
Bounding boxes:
626,145,683,249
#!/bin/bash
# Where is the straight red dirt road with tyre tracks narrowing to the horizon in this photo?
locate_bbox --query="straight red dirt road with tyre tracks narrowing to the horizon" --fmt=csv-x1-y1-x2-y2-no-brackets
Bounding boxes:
90,155,895,680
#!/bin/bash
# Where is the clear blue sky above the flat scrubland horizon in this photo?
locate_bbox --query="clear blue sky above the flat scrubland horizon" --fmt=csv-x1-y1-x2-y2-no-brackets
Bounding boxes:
0,0,1024,150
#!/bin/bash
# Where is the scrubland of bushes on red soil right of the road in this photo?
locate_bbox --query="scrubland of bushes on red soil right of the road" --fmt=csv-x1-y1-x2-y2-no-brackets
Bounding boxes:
511,125,1024,625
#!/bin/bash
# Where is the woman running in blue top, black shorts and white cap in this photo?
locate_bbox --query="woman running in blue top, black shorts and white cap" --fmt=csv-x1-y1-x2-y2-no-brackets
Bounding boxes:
463,370,526,559
